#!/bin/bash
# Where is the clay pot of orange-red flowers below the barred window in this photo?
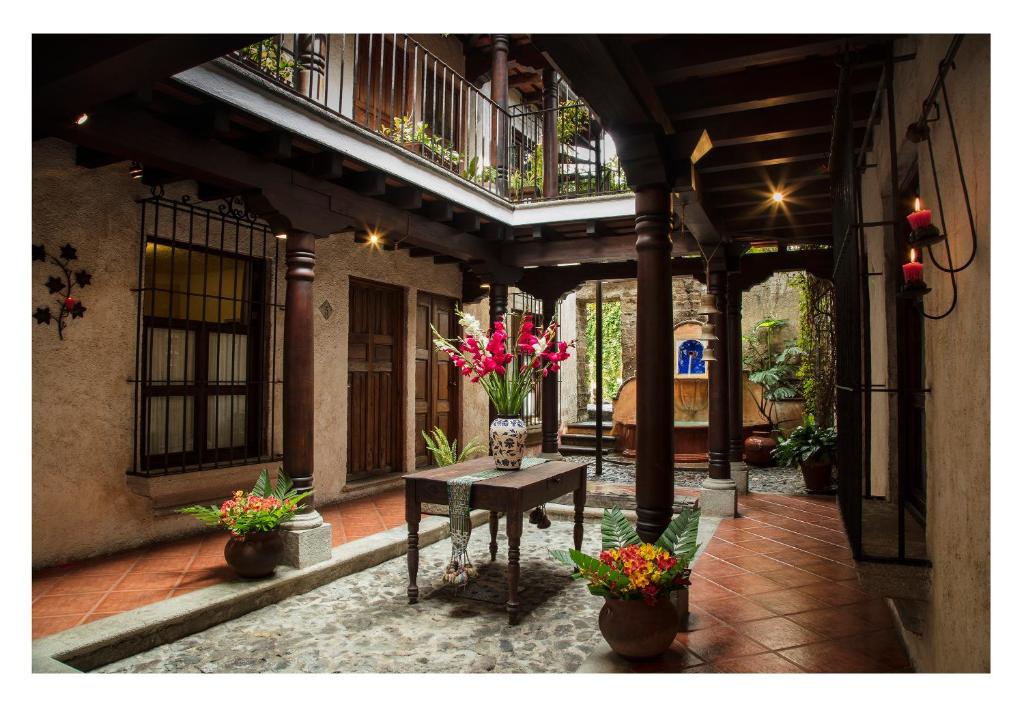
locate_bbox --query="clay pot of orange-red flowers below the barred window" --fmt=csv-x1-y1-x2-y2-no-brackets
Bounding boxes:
178,469,309,579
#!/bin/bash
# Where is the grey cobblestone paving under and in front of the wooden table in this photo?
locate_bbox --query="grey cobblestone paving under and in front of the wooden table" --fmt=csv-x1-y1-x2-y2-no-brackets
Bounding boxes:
100,521,603,672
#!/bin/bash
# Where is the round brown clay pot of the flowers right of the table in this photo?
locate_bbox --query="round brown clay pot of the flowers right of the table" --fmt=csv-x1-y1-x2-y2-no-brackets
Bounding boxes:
598,593,679,660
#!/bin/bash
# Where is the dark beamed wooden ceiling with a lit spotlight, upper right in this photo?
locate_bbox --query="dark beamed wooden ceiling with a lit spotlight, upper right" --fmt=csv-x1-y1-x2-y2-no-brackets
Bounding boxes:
534,35,889,251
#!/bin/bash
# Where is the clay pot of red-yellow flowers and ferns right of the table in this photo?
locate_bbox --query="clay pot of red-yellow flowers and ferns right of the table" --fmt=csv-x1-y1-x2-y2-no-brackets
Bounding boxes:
551,508,700,660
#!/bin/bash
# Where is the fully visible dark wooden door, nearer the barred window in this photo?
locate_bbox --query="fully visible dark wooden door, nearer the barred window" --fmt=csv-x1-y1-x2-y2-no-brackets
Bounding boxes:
348,279,406,480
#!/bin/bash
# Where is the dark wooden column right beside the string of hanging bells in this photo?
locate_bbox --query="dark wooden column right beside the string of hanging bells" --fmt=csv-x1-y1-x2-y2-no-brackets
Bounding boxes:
708,261,731,481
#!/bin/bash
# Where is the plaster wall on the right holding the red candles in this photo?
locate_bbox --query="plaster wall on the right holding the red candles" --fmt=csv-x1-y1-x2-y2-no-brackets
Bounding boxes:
864,35,990,671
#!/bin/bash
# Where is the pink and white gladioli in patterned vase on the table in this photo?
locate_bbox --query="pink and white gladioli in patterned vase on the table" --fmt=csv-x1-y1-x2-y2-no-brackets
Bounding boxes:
431,309,575,470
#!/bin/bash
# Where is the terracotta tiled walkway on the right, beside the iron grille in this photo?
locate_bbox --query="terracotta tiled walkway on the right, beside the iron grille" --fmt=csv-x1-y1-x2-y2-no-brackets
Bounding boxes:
633,494,909,672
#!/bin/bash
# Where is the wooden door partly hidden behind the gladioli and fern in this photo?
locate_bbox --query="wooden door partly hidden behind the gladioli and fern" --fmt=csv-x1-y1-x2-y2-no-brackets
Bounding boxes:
416,292,463,466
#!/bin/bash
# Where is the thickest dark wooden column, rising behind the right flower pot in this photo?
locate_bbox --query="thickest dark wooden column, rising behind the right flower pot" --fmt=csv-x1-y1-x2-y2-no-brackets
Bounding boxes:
636,184,675,542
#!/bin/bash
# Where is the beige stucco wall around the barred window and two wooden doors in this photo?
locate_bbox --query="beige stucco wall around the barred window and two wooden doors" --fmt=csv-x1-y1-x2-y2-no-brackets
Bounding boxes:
32,139,486,567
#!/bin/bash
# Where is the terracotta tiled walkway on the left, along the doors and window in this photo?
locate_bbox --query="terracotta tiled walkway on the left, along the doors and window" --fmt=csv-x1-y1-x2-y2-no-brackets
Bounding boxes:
32,489,406,638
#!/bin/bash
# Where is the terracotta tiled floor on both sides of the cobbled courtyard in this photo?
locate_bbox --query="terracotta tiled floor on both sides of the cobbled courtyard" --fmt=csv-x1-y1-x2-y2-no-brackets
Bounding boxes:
32,489,908,672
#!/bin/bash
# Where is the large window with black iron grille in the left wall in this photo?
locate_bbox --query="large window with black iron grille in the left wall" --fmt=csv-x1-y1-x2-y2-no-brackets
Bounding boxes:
132,196,282,475
